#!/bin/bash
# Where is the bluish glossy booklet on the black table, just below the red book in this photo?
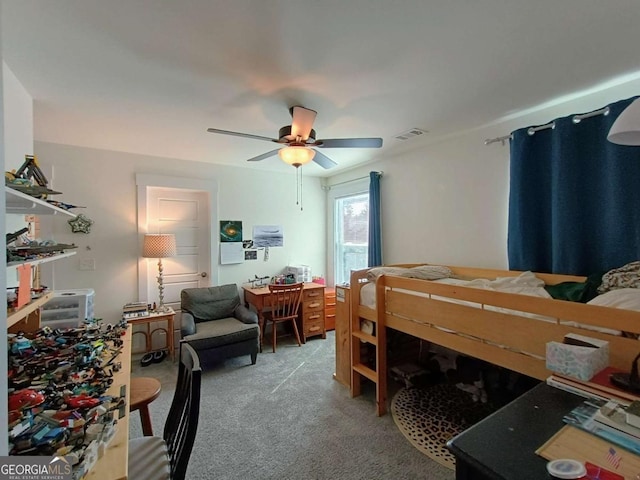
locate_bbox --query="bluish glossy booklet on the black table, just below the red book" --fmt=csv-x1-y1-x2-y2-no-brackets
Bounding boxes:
563,398,640,455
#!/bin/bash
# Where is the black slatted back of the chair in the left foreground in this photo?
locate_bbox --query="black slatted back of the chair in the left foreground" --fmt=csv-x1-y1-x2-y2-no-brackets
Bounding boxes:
163,342,202,480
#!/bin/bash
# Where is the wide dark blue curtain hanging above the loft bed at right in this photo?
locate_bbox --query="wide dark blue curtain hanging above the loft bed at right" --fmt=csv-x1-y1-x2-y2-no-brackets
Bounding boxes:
508,99,640,275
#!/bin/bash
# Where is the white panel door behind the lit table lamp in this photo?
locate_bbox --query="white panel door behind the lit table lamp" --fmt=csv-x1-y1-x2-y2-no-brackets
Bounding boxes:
146,187,211,311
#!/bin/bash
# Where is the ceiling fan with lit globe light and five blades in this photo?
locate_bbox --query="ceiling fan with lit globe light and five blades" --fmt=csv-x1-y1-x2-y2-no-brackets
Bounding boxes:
207,105,382,168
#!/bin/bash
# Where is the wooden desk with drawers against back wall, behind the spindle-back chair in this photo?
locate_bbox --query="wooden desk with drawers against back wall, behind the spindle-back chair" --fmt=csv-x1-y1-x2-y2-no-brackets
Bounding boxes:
242,283,327,351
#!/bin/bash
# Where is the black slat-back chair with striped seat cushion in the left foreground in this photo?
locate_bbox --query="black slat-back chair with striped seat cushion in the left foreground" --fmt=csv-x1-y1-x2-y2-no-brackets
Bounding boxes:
128,342,202,480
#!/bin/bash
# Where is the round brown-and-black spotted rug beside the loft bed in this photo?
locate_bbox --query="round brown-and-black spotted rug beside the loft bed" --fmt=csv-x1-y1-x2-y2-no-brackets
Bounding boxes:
391,384,493,470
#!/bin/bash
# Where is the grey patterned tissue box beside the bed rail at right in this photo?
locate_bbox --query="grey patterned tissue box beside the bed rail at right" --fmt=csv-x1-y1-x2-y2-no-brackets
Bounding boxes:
546,333,609,381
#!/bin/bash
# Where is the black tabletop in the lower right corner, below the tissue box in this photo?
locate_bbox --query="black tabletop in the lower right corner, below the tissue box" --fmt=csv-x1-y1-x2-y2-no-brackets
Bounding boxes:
448,383,584,480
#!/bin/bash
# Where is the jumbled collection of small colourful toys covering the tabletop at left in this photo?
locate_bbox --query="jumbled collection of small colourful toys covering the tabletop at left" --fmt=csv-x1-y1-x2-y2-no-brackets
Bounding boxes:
8,319,127,479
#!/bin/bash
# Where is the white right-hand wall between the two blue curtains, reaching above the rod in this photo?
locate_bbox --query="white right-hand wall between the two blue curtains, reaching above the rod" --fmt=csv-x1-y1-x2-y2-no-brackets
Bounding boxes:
327,79,640,269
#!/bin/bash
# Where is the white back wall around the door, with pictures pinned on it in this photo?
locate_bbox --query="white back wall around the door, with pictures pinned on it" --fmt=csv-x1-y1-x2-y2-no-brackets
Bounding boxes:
35,142,326,321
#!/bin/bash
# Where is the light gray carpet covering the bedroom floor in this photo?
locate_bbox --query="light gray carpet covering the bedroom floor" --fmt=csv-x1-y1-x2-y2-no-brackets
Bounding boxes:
130,332,455,480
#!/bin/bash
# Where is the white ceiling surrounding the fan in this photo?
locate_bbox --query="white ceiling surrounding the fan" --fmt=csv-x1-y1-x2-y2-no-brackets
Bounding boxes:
2,0,640,175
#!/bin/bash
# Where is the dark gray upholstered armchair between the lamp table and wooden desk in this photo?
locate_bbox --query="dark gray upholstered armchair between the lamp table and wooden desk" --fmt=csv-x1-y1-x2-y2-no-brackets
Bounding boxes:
180,284,260,365
